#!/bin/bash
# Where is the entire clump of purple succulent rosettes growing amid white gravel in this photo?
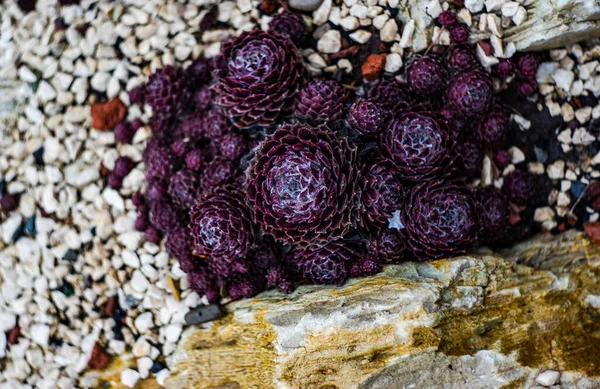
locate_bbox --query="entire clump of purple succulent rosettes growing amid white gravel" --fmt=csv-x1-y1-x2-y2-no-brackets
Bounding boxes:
124,10,537,301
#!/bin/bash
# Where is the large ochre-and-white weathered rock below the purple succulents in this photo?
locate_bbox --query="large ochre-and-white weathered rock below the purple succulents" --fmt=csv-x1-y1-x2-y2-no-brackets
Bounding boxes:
166,232,600,389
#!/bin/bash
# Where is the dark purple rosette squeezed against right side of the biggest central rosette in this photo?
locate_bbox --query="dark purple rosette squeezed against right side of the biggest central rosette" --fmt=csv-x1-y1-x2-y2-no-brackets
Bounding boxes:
359,158,405,228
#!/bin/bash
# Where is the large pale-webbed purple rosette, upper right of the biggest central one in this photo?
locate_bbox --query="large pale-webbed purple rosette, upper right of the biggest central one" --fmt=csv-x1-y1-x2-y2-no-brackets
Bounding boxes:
381,110,453,181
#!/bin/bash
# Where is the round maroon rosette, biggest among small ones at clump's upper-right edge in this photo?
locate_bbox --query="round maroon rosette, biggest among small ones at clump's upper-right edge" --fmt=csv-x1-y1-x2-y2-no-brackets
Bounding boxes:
446,70,494,118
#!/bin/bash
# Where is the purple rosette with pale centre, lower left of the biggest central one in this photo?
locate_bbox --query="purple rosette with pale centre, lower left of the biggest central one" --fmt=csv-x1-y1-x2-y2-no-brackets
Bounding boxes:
189,187,256,264
